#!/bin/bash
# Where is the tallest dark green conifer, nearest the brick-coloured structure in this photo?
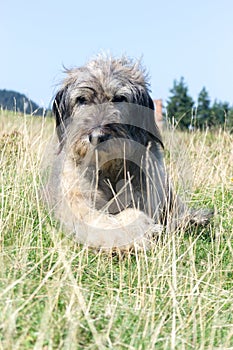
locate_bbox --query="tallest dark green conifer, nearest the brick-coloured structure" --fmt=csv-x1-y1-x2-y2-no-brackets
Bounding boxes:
167,77,194,130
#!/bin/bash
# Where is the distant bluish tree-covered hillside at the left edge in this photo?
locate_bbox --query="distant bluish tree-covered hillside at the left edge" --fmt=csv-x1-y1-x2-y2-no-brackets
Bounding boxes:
0,90,45,116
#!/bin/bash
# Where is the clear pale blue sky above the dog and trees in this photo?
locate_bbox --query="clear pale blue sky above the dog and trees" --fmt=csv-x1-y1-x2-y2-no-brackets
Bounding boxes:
0,0,233,107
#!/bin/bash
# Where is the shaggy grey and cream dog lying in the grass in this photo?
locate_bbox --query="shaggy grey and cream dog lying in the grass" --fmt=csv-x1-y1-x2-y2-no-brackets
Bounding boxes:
47,56,211,250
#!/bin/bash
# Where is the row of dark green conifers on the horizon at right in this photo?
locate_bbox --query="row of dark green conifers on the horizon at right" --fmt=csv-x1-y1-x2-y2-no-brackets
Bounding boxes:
166,77,233,130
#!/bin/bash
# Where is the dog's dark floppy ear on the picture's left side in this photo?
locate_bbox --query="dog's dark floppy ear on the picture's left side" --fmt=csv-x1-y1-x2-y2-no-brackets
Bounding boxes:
52,86,69,143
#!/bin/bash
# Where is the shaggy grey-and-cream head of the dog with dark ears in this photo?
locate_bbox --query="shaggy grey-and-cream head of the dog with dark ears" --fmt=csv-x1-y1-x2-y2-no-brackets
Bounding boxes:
53,56,162,163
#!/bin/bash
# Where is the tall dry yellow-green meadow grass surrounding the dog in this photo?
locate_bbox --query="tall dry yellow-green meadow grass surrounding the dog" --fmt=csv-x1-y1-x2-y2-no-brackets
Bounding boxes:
0,112,233,350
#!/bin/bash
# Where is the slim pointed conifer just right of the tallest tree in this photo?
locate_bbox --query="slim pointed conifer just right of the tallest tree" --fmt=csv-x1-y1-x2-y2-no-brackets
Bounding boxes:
196,87,211,128
